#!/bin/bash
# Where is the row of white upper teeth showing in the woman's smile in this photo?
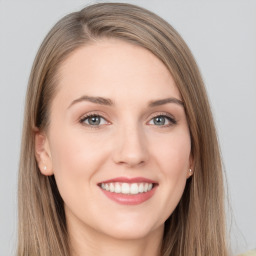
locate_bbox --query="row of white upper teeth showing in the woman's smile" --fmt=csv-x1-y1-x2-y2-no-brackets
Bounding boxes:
101,182,153,195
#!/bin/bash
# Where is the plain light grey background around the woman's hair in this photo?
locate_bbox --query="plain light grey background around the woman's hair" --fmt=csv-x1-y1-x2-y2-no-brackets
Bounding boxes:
0,0,256,256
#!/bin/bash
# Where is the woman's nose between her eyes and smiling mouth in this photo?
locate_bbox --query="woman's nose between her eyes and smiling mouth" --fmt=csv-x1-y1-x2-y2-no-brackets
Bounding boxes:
113,126,149,168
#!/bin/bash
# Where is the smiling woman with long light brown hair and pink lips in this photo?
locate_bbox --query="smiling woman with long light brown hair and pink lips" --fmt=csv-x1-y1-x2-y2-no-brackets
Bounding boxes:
18,3,227,256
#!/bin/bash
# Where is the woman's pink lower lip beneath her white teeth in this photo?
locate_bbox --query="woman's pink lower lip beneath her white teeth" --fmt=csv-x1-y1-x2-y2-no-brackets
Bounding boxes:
100,186,156,205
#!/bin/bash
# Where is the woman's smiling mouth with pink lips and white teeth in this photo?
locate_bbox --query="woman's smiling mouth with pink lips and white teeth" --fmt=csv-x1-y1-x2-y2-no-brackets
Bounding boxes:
98,177,158,205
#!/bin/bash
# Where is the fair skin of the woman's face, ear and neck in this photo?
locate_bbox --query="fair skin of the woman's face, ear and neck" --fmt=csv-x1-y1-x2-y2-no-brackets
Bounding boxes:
36,39,192,256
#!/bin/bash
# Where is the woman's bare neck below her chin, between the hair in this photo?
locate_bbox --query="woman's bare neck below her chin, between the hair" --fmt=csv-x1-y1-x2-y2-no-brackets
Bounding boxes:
68,218,163,256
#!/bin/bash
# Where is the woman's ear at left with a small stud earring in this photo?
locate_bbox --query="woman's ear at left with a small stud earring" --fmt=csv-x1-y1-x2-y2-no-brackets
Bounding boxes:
34,130,53,176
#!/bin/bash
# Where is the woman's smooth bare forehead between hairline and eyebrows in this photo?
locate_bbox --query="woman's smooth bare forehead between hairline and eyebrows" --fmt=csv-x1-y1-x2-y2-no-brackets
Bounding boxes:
55,39,180,106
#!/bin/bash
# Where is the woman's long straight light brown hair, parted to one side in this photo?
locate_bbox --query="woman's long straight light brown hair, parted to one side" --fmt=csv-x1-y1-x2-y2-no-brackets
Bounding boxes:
17,3,227,256
